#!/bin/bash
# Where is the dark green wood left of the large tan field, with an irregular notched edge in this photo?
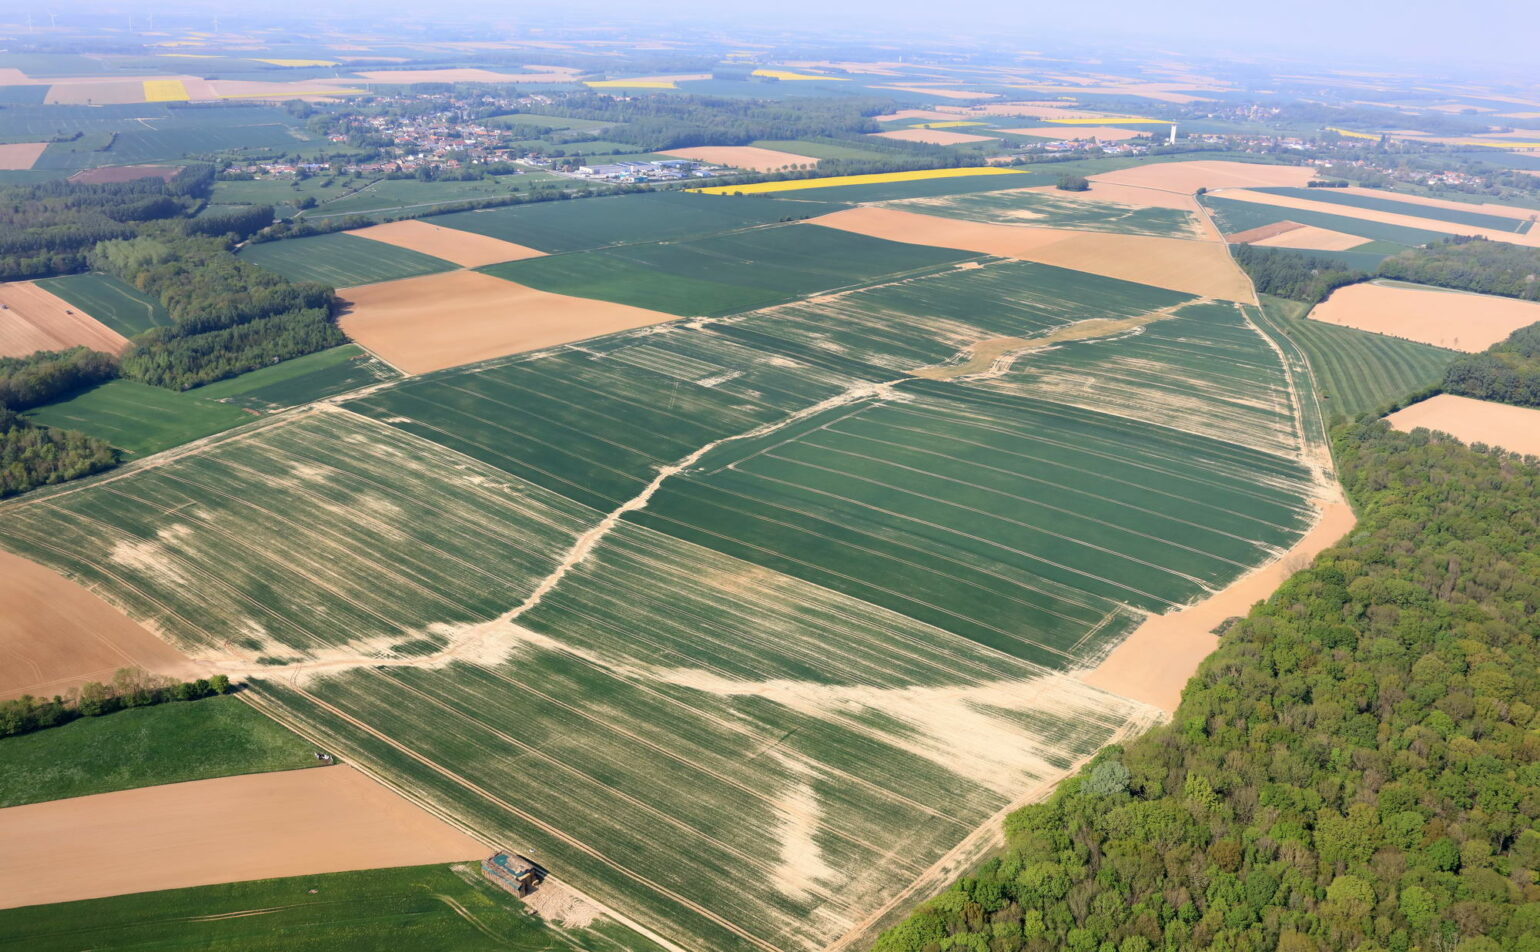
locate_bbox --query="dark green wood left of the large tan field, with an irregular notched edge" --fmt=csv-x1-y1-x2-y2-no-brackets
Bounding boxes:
91,231,347,390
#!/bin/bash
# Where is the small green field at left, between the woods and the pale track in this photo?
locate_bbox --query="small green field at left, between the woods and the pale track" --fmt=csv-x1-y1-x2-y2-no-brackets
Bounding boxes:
26,380,251,456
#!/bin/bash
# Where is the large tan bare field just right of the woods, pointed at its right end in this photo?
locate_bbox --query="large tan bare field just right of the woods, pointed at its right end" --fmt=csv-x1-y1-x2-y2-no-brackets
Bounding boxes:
337,271,678,373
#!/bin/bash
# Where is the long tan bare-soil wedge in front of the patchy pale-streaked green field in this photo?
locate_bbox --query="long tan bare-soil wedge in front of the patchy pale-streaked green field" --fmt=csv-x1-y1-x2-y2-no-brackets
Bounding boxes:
813,206,1255,302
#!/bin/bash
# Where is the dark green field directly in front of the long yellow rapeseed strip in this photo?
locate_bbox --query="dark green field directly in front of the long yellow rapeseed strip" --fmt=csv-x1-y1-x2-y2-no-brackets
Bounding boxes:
430,191,830,253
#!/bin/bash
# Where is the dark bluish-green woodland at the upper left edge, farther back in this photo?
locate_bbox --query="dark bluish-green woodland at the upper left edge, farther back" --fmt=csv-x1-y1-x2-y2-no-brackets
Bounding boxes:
0,165,214,280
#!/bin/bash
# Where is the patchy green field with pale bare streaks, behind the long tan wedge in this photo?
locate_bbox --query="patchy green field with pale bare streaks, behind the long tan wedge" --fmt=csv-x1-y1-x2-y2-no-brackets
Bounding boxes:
893,189,1201,237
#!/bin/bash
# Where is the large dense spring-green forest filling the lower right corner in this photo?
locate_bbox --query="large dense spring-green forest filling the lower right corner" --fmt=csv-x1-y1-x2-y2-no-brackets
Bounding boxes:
876,422,1540,952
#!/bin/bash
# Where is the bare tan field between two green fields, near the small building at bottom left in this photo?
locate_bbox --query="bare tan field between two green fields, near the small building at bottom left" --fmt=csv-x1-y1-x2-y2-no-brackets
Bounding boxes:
0,764,490,907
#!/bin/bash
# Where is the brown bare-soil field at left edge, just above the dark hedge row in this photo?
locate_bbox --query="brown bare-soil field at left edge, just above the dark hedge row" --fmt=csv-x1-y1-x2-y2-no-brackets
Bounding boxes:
0,545,206,701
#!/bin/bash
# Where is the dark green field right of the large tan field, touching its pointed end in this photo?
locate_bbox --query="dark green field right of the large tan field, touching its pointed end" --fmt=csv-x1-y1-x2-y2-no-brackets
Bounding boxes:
480,220,975,317
